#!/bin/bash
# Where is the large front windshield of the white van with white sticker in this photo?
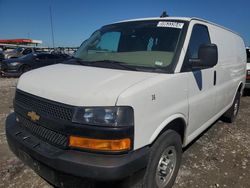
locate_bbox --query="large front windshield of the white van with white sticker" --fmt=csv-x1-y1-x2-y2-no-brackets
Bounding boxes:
74,21,184,70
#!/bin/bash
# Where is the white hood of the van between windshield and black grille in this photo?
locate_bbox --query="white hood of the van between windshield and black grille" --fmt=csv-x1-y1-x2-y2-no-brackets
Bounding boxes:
17,64,155,106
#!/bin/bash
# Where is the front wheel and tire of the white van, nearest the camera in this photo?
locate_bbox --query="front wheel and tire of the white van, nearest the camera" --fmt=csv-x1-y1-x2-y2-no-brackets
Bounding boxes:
143,130,182,188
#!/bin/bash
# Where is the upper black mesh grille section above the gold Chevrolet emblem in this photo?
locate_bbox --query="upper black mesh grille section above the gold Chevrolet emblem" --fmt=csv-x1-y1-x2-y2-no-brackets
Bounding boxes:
15,90,74,121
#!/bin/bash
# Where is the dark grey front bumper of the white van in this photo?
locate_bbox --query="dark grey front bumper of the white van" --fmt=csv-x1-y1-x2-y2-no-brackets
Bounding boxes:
6,113,150,186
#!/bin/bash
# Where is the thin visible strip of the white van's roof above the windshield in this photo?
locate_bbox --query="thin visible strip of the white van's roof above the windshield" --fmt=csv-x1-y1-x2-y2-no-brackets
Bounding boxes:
116,17,240,36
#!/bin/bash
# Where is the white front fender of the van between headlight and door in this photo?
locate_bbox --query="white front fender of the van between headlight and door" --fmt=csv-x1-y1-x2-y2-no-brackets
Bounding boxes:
117,74,188,149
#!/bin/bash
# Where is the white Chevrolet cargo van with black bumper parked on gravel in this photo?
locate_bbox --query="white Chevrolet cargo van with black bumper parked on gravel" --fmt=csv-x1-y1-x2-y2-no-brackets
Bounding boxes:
6,17,247,188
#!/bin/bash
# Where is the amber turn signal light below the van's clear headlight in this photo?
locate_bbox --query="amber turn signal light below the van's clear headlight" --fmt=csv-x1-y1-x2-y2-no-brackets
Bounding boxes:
69,136,131,151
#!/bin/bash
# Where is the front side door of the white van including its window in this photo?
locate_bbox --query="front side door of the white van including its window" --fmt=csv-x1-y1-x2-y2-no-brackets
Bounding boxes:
182,21,216,140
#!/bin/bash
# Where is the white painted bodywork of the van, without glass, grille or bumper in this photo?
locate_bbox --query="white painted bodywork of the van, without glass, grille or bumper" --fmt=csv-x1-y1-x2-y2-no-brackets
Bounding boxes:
17,18,246,149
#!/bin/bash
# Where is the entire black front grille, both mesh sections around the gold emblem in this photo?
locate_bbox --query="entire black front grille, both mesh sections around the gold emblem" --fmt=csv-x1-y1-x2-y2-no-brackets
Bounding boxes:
14,90,74,148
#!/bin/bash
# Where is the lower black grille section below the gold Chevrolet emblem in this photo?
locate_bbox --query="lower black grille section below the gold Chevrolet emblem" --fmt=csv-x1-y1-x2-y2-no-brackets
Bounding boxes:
17,115,67,148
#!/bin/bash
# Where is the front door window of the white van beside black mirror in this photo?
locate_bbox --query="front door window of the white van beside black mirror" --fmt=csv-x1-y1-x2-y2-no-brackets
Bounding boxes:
182,24,211,71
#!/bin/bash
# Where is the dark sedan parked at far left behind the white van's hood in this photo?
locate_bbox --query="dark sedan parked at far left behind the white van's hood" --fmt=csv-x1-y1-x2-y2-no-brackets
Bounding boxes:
0,53,68,76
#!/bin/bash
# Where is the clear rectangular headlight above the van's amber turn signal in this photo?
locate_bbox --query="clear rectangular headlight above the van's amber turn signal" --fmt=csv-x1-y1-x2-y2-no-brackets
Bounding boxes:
73,106,134,126
